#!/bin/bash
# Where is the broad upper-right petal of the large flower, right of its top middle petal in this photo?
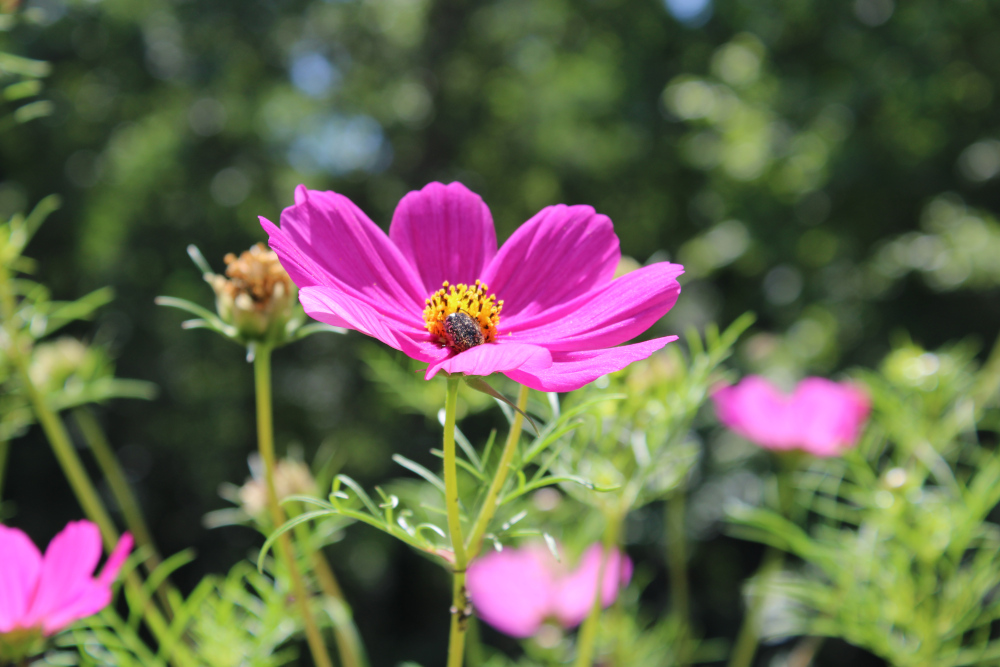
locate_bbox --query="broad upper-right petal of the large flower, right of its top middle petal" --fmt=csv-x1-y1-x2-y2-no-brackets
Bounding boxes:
482,204,621,326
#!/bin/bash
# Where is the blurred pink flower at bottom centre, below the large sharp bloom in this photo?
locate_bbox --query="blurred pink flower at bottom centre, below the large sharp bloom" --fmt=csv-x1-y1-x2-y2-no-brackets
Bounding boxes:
466,544,632,637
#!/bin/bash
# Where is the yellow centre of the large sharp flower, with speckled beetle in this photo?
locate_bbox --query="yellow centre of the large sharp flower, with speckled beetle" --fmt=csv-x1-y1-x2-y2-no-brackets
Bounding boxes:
424,280,503,352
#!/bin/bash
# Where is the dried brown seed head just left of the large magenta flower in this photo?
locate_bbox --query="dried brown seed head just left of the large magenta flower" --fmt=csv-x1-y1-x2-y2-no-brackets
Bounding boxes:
205,243,298,340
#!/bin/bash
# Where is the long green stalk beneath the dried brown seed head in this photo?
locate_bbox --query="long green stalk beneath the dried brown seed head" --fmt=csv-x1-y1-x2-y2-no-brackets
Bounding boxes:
253,345,338,667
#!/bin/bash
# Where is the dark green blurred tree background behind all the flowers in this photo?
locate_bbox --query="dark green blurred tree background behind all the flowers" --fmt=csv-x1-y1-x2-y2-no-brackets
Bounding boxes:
0,0,1000,665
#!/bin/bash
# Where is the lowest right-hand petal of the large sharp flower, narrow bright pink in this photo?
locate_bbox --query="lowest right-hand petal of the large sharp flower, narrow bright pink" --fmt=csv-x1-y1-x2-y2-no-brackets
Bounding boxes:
504,336,677,391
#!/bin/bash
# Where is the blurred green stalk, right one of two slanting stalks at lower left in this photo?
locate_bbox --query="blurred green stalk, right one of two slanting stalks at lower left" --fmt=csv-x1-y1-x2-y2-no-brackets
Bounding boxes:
73,408,173,618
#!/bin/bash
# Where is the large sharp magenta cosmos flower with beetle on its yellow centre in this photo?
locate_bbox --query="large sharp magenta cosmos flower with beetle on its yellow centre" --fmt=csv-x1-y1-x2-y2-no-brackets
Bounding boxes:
261,183,683,391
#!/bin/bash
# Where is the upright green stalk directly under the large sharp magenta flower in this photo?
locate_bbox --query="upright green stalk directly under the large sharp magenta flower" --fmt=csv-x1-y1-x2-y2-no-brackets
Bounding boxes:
443,375,470,667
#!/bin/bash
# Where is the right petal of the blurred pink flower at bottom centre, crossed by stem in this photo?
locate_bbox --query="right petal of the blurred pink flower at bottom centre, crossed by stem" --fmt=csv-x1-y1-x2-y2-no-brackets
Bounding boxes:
554,544,632,628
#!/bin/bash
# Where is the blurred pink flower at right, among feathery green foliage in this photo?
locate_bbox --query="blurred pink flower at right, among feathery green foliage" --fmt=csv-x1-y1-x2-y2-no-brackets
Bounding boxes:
712,375,871,457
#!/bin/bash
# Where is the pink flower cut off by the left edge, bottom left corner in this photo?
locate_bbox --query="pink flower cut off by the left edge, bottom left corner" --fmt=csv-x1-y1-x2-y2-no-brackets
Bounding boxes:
0,521,132,644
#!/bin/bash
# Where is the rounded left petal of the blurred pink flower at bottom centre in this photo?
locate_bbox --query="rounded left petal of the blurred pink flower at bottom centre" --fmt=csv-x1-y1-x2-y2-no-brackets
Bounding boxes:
466,549,554,637
